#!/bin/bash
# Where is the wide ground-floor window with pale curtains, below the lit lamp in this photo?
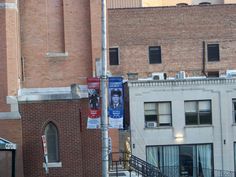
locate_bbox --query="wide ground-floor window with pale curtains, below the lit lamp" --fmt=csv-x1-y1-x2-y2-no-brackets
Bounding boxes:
146,144,214,177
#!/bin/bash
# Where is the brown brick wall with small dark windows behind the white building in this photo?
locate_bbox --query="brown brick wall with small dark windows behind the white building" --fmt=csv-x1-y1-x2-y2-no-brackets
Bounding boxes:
109,5,236,76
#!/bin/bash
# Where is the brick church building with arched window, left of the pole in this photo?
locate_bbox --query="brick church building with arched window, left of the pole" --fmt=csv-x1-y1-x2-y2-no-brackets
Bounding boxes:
0,0,105,177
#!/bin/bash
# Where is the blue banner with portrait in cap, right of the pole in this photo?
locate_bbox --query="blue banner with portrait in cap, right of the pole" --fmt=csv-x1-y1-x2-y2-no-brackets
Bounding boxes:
108,77,124,129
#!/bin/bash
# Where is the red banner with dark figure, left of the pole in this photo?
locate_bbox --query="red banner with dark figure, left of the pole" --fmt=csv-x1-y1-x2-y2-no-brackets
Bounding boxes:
87,78,101,129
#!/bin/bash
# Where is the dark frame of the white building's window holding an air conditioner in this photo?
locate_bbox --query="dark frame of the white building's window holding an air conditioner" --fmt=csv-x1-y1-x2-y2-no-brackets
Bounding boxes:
144,101,172,128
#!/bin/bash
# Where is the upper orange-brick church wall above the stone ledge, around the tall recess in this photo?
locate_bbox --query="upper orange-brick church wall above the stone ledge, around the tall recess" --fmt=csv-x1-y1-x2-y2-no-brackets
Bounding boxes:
20,0,92,87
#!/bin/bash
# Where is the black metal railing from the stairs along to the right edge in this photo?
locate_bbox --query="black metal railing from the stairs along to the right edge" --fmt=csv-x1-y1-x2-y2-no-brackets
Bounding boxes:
109,152,236,177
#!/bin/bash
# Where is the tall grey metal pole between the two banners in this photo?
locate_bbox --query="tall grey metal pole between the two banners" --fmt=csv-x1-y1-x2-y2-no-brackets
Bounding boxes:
101,0,109,177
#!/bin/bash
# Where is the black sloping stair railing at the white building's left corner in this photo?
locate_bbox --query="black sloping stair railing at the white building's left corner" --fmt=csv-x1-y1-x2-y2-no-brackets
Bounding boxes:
109,152,167,177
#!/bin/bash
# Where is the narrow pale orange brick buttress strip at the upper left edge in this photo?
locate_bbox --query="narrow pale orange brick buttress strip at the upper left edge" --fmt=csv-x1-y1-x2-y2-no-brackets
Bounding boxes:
0,1,20,112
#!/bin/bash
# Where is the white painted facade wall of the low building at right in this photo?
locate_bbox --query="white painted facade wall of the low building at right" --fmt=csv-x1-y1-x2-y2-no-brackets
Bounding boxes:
129,79,236,171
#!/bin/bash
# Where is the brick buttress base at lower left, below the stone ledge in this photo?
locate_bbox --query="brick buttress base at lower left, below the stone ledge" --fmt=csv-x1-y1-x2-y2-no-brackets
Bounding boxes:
0,120,23,177
